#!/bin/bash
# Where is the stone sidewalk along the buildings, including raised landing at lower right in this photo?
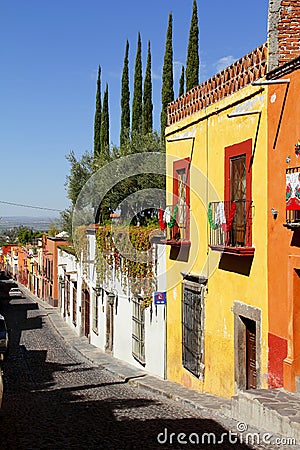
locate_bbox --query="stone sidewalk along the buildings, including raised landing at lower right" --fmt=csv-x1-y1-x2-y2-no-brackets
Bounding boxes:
20,286,300,448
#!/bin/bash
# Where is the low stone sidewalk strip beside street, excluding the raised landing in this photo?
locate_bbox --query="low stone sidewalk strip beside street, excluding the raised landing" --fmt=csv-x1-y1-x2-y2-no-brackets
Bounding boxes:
19,285,300,449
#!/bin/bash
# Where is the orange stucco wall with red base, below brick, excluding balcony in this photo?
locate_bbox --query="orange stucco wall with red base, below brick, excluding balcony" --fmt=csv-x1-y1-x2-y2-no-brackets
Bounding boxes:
268,70,300,390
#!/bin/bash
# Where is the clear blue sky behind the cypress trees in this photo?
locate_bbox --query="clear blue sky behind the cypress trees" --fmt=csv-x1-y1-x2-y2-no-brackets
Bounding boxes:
0,0,268,217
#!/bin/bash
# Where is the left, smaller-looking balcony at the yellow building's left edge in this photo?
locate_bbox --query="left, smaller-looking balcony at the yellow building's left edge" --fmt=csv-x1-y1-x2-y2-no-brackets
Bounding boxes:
159,205,190,246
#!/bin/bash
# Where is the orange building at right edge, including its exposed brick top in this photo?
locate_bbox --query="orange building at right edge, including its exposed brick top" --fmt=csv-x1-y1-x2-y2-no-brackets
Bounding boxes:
265,0,300,391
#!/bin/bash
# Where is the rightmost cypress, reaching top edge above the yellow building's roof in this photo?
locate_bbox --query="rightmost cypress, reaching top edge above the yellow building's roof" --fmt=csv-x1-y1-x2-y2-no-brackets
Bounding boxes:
185,0,199,91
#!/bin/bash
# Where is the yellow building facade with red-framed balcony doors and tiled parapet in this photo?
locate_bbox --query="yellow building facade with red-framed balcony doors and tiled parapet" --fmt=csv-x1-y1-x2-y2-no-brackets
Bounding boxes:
166,45,268,397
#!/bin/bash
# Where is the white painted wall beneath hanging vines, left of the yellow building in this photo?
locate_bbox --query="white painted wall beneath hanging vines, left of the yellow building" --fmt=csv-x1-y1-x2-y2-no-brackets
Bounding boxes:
76,232,166,378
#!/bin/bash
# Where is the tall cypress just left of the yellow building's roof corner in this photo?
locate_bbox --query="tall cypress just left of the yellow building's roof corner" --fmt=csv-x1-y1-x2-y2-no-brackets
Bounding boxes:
160,13,174,142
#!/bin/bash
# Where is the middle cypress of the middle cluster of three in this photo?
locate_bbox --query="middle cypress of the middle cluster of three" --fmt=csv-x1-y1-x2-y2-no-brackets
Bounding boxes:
131,33,143,134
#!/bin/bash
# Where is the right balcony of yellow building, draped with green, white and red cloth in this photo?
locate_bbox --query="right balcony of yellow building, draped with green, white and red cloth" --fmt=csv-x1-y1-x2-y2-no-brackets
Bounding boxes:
208,200,255,256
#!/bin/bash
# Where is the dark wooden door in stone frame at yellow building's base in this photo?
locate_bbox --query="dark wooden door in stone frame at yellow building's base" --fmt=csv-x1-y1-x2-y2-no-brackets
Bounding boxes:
246,320,257,389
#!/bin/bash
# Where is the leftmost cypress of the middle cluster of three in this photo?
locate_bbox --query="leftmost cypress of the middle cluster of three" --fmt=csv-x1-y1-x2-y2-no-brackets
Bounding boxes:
120,40,130,147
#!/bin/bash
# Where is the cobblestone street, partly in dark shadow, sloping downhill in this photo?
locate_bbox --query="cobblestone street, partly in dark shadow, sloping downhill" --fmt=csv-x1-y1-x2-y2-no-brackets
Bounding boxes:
0,299,292,450
